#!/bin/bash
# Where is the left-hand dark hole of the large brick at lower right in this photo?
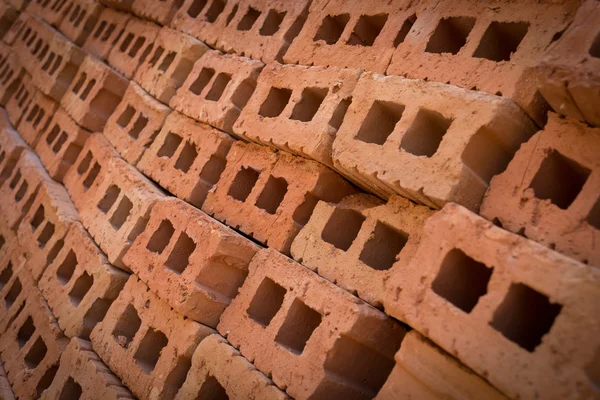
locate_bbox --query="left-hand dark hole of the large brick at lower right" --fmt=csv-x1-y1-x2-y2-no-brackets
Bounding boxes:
431,249,493,313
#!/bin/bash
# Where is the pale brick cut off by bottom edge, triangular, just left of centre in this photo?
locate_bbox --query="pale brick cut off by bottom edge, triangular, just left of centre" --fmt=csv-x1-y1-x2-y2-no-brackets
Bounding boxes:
175,335,289,400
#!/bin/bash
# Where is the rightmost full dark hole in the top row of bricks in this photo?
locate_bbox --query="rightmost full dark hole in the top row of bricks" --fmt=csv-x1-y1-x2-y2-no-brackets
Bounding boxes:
473,21,529,61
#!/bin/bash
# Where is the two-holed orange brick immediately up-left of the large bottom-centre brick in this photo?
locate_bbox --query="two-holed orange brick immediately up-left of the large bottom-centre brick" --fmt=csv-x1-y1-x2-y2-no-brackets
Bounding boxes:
123,198,259,328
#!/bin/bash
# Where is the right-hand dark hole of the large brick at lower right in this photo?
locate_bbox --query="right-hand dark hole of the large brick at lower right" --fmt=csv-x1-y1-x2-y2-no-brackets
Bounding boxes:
490,283,562,352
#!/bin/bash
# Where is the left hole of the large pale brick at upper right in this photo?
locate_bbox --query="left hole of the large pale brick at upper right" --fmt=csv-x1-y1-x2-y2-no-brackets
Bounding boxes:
356,100,404,145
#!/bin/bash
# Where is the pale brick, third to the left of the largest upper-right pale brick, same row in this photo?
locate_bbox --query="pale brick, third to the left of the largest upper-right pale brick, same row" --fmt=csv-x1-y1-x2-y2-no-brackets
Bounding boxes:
134,26,209,104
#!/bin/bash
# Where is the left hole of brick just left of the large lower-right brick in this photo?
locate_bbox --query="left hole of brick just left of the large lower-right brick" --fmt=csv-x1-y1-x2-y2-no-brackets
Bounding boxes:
321,208,365,251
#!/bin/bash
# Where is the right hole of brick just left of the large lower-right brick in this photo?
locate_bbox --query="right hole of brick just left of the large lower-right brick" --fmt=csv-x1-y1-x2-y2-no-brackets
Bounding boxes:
359,221,408,271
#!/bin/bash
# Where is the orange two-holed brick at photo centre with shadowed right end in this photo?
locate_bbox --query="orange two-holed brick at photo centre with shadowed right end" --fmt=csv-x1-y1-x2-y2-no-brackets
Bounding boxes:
202,142,355,254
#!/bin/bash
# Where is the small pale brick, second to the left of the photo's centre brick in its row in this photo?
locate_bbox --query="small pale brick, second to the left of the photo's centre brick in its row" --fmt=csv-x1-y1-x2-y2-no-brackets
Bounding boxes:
104,81,171,165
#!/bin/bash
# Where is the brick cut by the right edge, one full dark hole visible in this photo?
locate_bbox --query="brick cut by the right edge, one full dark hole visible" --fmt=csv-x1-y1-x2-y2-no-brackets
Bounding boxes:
481,113,600,266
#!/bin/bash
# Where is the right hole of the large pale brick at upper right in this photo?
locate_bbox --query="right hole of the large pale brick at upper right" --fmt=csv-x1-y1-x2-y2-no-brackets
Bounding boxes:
400,108,452,157
